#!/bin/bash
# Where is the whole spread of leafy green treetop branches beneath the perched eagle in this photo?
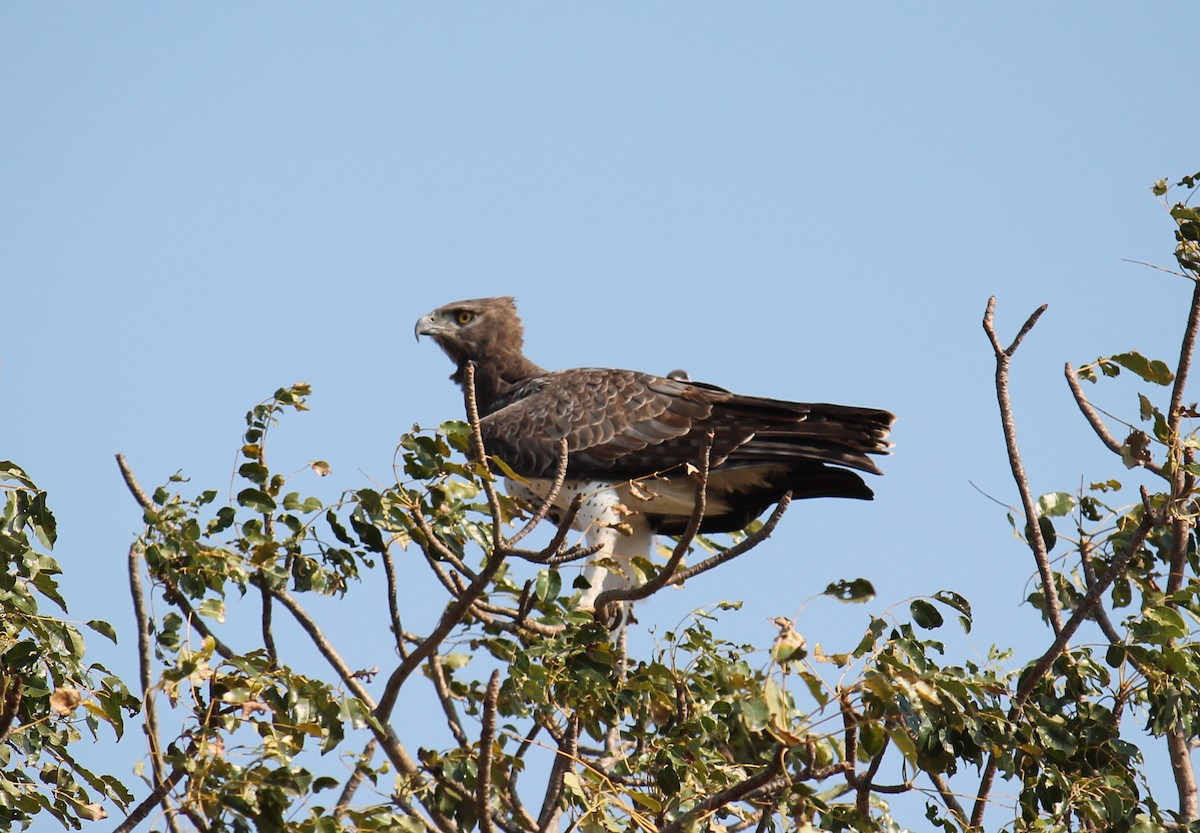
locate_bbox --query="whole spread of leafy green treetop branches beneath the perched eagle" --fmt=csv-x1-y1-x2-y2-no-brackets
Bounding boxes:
7,174,1200,833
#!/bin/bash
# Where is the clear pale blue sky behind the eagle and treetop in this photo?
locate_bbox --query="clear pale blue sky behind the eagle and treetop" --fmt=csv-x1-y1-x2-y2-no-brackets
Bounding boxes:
0,2,1200,822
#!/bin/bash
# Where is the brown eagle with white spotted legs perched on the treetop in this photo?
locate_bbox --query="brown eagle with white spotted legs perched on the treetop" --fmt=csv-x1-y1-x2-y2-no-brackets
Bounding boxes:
415,296,894,616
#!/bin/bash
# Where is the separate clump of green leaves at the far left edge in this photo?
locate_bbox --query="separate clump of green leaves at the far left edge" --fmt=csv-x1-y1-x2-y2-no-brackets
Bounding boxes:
0,461,139,829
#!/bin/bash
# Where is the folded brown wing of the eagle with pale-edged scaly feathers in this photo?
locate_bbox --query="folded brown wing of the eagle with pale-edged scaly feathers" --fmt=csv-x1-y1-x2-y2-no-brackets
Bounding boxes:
481,368,892,482
